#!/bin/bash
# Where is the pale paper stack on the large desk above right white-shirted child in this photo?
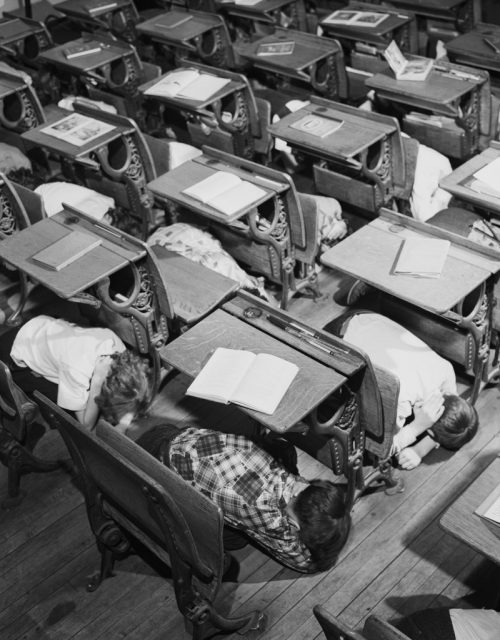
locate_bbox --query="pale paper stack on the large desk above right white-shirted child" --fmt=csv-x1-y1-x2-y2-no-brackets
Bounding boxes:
393,237,450,278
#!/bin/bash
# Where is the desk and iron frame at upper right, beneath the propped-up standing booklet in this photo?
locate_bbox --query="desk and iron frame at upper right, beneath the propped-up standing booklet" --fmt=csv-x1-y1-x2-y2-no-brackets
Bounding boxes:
366,61,494,158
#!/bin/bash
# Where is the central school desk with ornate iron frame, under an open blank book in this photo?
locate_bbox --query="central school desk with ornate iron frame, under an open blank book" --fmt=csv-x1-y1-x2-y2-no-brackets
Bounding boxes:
148,147,318,308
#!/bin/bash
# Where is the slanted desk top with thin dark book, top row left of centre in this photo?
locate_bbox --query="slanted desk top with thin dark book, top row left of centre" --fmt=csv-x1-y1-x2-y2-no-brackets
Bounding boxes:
136,9,224,51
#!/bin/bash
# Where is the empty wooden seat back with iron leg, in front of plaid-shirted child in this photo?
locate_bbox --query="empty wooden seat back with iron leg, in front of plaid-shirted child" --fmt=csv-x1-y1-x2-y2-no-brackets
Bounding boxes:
35,392,262,640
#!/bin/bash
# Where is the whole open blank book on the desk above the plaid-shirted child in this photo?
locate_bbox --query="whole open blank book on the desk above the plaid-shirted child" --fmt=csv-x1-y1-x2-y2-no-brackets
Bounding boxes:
186,347,299,415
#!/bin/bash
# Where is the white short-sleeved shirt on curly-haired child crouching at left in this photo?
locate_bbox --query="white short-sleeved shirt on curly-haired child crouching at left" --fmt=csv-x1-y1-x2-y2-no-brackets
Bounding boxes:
10,315,125,411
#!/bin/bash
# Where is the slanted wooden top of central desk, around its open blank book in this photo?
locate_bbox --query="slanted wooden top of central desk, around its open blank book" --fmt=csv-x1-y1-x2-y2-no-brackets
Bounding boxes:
148,155,289,223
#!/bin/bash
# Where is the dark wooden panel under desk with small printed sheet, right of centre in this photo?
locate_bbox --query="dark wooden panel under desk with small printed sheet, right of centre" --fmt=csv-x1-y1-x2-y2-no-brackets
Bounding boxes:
314,165,376,213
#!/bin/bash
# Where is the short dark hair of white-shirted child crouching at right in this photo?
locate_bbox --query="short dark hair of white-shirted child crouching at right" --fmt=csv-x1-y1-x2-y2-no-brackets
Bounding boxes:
432,395,479,451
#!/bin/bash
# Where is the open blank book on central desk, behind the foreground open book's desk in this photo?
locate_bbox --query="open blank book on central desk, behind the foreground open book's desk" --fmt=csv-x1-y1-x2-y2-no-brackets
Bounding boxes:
182,171,267,216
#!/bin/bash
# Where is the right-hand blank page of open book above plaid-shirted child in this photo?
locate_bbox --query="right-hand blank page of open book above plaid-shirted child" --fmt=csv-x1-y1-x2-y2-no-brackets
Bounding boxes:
230,353,299,415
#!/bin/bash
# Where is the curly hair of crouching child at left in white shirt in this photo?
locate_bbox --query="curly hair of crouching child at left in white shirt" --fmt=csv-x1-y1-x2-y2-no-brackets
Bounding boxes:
95,349,153,425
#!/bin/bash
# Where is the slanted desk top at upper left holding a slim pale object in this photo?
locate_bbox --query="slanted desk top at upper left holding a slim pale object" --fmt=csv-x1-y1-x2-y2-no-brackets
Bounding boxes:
39,36,135,73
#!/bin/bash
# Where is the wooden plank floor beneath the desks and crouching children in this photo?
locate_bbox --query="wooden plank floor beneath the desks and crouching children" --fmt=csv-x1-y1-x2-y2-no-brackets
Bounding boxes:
0,270,500,640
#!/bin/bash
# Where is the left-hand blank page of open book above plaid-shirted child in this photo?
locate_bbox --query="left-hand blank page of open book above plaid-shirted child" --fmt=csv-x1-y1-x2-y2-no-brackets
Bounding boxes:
186,347,256,404
